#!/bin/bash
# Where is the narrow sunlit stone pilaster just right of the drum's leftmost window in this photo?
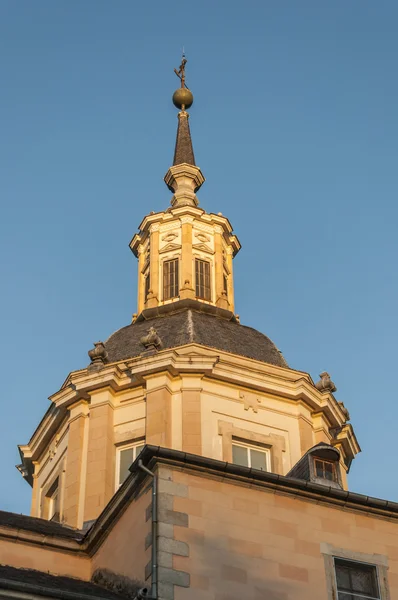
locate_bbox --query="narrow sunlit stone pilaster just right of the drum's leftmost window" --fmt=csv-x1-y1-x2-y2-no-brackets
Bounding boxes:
63,400,88,527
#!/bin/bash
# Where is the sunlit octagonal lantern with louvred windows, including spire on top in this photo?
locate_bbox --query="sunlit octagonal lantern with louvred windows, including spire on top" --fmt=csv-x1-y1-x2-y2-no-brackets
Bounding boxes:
130,56,240,319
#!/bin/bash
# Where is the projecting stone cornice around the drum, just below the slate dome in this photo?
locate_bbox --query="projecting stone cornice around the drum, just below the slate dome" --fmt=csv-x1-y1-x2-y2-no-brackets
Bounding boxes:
20,344,359,474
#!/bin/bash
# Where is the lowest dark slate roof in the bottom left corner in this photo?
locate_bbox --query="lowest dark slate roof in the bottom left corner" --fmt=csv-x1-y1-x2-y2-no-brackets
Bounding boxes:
0,565,125,600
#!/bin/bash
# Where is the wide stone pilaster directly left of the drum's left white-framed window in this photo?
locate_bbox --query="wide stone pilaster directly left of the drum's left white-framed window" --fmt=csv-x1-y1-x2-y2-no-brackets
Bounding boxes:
83,390,115,521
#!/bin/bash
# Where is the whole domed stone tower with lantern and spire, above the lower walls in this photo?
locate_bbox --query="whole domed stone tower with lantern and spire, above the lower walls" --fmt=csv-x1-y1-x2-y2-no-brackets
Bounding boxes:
18,59,359,528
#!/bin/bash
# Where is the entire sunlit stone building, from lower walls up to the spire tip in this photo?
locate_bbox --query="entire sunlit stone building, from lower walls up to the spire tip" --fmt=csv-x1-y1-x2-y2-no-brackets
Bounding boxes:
0,58,398,600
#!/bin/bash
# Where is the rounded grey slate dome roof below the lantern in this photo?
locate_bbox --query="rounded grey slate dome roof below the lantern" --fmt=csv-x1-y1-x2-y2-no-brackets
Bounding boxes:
105,308,288,367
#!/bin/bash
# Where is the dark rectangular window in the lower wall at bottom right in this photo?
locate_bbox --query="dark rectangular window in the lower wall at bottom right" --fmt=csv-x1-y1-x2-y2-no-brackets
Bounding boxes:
334,558,381,600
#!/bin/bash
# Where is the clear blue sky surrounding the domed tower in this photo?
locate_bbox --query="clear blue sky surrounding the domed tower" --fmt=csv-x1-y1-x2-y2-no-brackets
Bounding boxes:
0,0,398,512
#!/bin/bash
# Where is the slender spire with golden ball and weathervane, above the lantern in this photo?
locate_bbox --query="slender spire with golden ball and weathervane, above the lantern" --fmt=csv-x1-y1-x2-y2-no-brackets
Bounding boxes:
164,54,205,207
